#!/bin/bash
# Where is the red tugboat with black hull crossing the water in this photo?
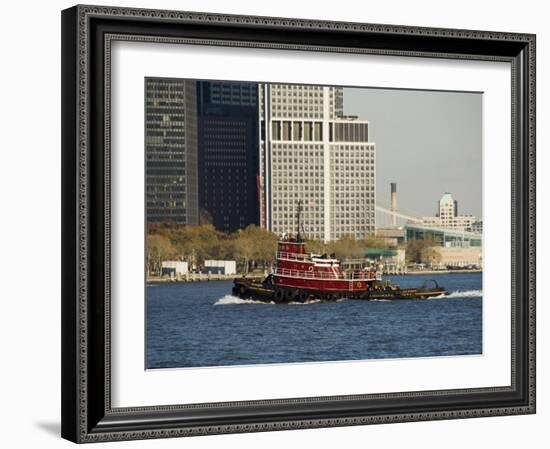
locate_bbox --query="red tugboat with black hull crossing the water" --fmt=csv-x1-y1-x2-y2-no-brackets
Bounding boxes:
232,203,448,304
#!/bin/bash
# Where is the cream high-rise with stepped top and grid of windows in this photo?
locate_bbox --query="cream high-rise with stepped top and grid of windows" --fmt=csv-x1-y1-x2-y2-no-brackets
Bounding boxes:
259,84,375,241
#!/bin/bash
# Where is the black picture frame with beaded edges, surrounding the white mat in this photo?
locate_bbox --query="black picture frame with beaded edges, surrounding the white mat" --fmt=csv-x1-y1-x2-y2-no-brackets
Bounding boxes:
62,6,535,443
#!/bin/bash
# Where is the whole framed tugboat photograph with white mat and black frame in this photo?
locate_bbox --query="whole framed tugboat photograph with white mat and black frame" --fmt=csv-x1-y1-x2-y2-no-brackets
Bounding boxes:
62,6,535,443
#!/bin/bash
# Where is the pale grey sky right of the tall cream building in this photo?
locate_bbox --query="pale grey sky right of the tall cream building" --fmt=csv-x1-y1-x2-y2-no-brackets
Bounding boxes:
344,88,483,225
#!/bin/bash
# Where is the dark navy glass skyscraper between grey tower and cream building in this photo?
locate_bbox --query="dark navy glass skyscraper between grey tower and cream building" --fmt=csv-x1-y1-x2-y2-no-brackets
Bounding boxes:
197,81,259,232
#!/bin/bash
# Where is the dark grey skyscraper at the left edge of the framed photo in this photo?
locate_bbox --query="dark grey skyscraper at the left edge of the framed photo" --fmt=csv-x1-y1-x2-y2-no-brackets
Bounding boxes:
145,78,199,225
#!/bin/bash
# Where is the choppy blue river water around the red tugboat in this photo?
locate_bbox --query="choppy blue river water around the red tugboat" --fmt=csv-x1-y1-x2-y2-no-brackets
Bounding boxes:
146,273,482,369
